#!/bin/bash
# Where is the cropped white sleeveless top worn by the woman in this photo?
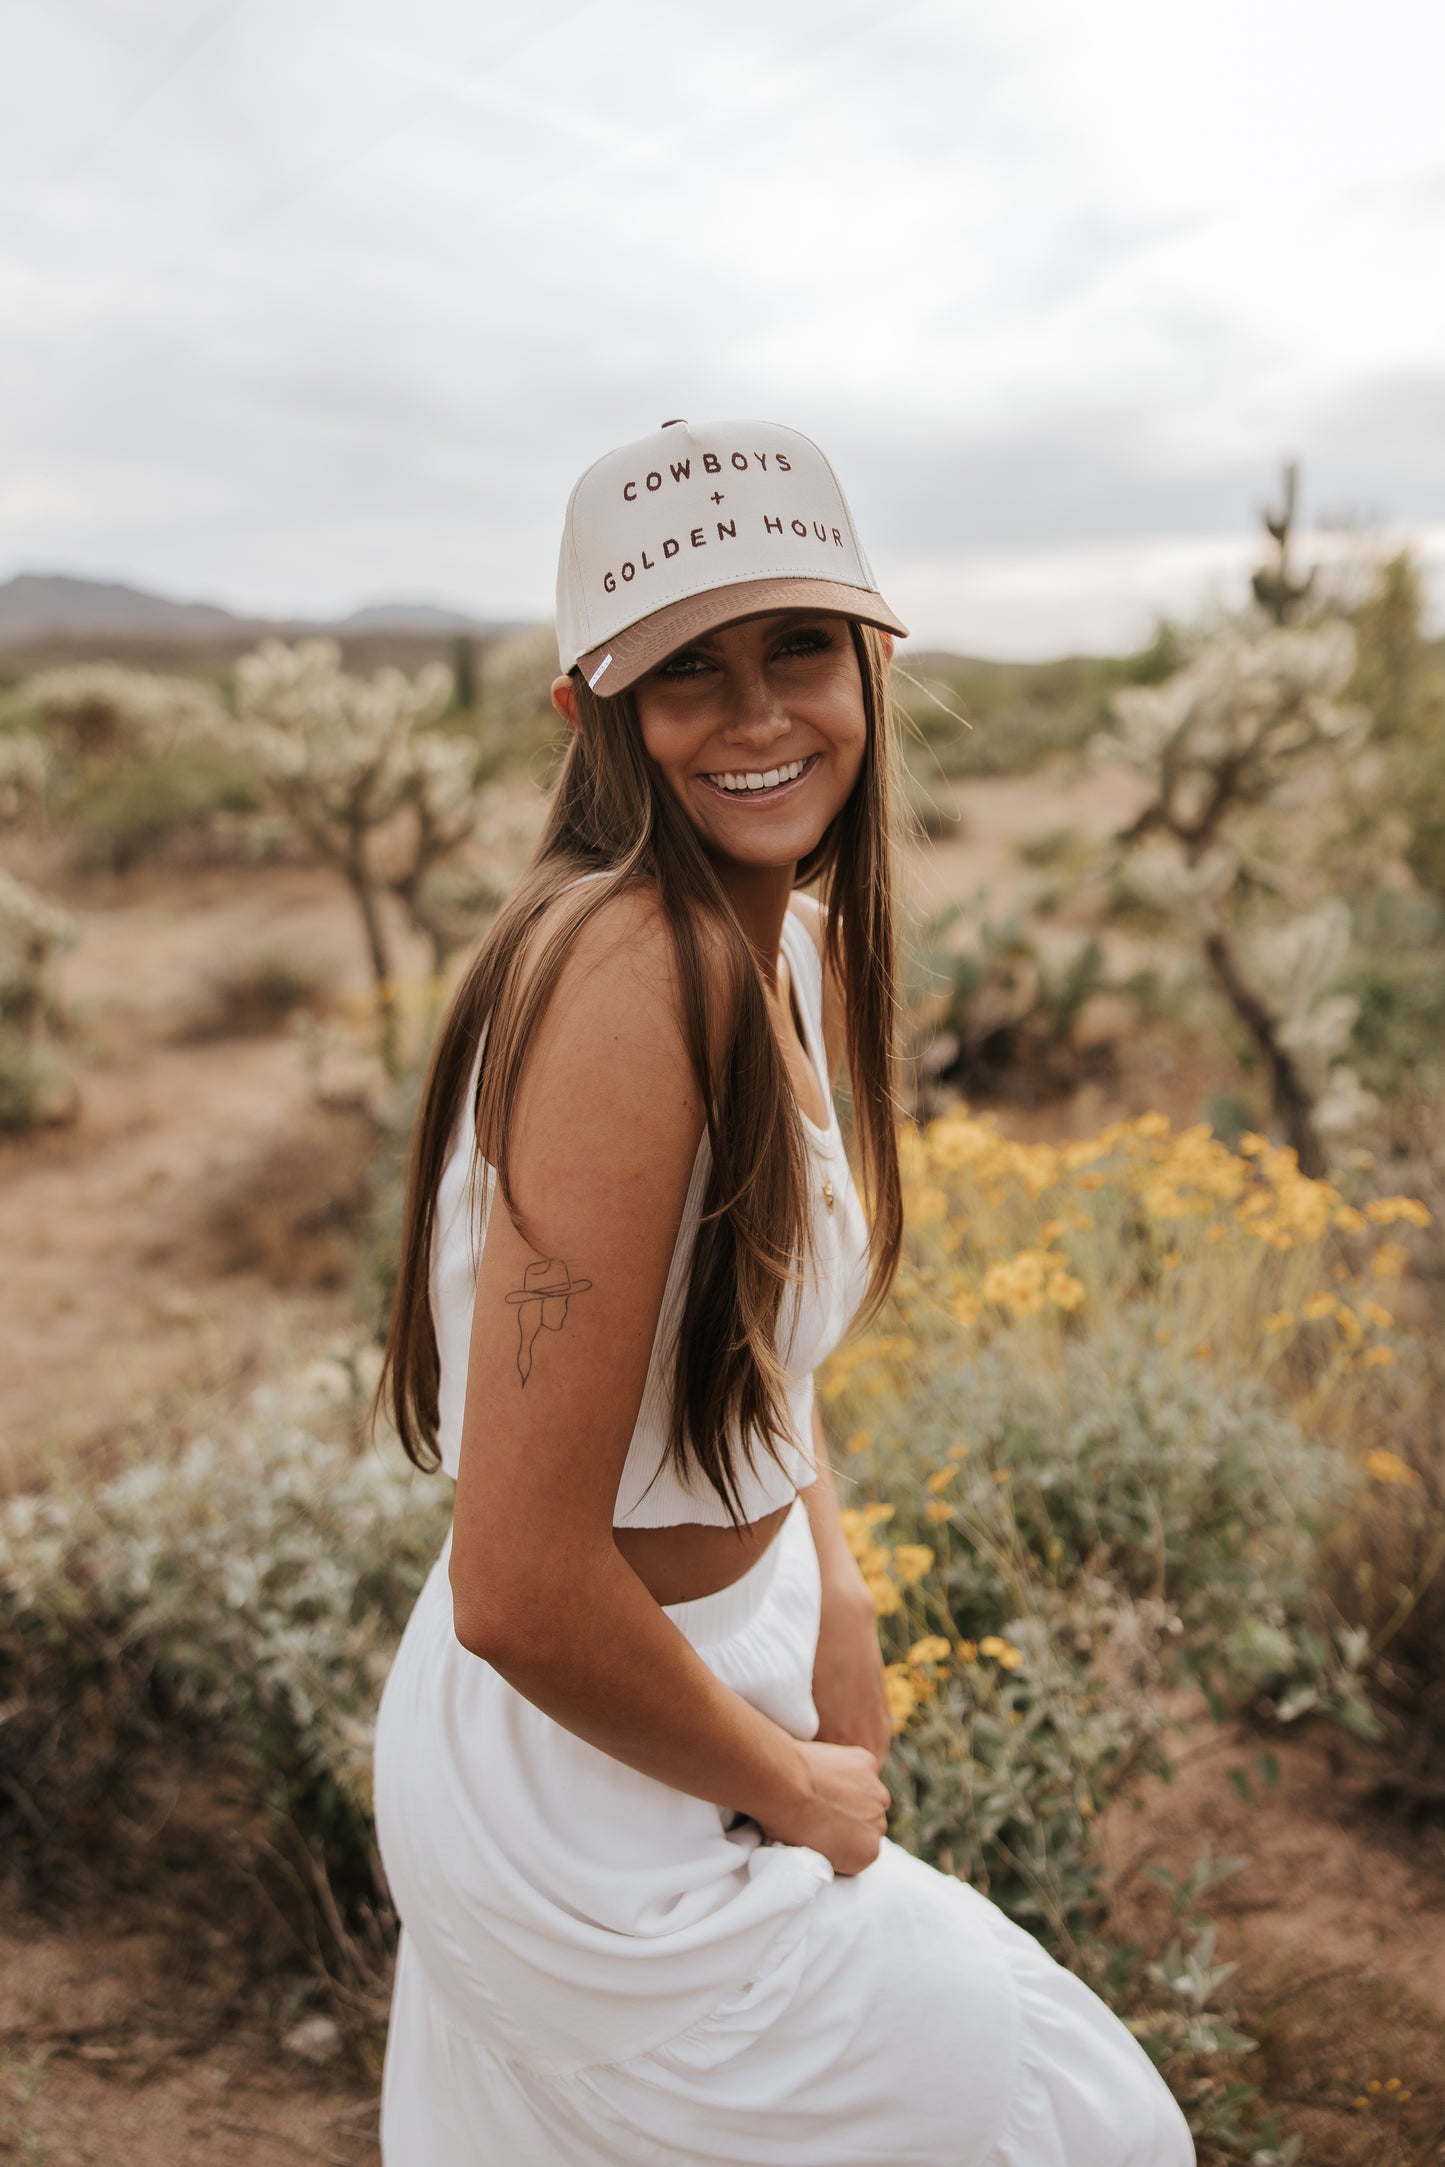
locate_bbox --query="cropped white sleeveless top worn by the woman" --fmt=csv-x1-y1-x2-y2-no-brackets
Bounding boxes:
431,873,869,1528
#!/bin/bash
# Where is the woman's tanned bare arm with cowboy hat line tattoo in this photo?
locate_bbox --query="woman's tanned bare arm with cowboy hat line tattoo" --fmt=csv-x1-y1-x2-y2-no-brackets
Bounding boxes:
451,899,886,1872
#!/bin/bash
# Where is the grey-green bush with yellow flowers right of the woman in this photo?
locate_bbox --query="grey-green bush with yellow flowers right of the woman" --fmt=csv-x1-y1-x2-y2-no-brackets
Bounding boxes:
821,1112,1428,1937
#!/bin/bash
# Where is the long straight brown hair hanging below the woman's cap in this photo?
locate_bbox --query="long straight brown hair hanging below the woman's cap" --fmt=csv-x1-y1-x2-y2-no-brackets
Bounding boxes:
373,620,903,1521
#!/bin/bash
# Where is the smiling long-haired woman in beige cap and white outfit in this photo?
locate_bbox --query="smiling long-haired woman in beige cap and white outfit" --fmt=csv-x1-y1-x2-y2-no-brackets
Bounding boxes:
377,423,1194,2167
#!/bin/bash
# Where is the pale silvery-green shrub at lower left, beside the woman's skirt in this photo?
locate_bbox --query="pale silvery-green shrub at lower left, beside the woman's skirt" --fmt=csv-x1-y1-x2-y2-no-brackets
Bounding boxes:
0,1359,451,1907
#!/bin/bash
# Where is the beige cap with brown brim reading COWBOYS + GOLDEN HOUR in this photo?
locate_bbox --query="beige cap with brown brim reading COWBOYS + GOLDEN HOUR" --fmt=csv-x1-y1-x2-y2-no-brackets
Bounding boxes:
557,420,908,693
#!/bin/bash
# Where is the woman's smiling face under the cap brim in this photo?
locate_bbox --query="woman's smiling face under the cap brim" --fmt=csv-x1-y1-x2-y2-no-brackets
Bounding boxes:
633,609,867,867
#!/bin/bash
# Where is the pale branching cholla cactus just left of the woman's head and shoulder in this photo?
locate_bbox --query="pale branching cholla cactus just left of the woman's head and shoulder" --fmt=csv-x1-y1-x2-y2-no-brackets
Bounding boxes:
236,639,479,1066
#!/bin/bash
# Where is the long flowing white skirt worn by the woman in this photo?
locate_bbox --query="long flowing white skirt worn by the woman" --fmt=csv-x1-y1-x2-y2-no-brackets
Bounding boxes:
377,1502,1194,2167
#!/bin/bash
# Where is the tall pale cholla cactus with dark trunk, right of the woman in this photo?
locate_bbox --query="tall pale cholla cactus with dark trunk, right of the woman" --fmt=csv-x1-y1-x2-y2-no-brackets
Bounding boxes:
1101,613,1374,1175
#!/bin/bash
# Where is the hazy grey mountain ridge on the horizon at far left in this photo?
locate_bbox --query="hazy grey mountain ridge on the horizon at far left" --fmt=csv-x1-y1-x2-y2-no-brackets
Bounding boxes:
0,572,505,646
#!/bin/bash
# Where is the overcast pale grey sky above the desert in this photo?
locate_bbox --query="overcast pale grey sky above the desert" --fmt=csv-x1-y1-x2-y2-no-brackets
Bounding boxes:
0,0,1445,654
